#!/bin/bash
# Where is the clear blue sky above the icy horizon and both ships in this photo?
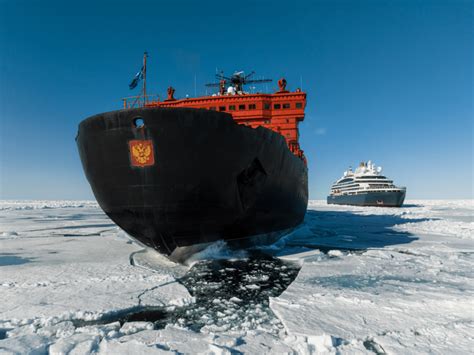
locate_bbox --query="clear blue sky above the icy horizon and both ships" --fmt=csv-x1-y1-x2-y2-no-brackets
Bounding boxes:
0,0,474,199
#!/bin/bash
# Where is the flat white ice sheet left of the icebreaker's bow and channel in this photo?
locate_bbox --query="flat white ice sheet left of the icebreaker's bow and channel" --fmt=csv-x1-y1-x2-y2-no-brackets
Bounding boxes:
0,201,193,353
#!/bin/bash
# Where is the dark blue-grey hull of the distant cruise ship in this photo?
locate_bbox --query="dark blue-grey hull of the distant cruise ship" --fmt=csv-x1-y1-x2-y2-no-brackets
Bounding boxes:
327,190,405,207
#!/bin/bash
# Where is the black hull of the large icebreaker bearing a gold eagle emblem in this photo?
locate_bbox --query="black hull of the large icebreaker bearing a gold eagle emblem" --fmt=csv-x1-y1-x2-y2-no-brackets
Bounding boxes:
76,108,308,255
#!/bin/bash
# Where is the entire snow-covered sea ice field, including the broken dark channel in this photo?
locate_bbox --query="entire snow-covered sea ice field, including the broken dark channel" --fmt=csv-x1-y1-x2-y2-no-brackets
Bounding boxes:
0,200,474,354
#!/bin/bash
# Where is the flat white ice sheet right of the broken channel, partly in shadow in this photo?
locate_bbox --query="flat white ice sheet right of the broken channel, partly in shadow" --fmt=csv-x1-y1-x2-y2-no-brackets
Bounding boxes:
271,201,474,354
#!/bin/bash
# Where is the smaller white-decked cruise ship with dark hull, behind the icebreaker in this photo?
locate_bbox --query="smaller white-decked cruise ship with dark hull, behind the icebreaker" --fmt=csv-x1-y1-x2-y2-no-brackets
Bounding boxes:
327,160,406,207
